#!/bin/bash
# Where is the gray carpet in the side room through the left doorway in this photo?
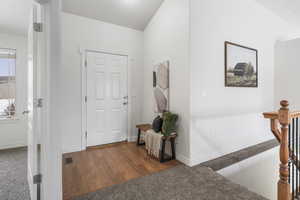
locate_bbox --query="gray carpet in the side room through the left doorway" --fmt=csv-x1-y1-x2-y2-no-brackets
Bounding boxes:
0,148,30,200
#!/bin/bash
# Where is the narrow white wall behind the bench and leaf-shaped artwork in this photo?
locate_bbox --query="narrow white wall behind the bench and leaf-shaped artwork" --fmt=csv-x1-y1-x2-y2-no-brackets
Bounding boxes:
143,0,190,163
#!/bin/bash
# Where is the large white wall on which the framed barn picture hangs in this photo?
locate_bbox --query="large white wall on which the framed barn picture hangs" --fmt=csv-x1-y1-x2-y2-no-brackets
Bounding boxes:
190,0,299,165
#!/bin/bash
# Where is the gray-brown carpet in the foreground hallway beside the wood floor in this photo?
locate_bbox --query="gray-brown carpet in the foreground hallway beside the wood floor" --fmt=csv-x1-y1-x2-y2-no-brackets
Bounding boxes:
72,166,266,200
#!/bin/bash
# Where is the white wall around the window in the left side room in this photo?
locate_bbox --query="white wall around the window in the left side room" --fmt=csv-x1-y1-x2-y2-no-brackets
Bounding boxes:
0,33,27,149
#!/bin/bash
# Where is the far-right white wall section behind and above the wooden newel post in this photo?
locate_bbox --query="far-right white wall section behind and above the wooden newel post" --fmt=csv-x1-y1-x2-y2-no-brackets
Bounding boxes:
275,39,300,111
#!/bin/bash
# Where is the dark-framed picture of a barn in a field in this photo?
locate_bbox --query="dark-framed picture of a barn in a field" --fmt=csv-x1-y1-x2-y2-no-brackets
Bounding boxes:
225,41,258,87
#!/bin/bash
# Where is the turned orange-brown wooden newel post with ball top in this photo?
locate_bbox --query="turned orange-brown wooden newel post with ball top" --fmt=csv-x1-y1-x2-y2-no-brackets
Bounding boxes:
278,101,291,200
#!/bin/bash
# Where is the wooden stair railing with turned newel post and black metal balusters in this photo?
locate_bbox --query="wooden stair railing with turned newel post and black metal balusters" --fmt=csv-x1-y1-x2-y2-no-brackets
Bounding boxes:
263,100,300,200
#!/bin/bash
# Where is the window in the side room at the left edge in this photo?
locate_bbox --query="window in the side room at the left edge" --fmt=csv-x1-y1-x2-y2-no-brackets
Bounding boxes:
0,48,16,119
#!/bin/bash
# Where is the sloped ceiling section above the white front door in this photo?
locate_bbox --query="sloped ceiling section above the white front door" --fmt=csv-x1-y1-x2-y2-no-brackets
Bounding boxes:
63,0,163,30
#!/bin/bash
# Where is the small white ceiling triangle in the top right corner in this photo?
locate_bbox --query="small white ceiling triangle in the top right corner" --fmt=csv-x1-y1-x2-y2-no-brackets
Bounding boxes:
256,0,300,27
